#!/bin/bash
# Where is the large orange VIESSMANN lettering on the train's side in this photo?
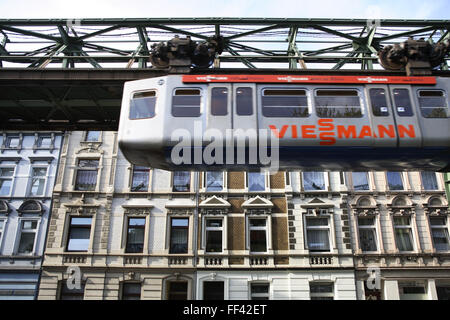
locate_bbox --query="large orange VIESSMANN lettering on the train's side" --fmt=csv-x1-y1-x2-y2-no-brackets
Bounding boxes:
269,119,416,146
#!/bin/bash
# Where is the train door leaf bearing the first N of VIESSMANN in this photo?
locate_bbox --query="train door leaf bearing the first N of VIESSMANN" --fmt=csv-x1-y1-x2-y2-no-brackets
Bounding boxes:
366,85,398,147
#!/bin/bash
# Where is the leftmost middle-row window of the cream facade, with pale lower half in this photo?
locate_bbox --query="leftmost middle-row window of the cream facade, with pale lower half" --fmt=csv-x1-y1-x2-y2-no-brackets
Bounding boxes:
67,217,92,252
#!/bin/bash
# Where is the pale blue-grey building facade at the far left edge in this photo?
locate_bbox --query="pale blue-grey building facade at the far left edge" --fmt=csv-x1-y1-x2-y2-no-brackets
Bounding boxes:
0,131,62,300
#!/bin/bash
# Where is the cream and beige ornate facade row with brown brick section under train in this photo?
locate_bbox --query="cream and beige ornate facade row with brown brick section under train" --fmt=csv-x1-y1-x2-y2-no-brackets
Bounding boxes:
38,131,450,300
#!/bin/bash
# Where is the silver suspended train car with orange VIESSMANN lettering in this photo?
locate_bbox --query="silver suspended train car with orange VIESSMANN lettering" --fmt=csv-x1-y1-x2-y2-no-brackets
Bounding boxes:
118,74,450,171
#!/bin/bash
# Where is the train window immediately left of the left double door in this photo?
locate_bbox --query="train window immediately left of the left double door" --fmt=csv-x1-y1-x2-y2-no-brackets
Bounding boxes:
172,89,201,117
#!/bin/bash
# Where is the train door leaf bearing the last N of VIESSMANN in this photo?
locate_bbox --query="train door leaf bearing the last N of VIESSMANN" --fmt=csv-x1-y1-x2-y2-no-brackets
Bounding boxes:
389,85,422,147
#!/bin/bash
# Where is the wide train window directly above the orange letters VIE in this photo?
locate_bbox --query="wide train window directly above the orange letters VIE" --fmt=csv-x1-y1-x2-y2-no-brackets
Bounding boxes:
262,89,309,118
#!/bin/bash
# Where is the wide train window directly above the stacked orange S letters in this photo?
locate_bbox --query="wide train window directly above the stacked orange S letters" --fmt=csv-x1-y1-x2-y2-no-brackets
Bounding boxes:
314,90,362,118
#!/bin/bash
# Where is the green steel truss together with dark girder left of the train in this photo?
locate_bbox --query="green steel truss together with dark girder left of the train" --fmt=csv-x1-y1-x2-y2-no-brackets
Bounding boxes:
0,18,450,130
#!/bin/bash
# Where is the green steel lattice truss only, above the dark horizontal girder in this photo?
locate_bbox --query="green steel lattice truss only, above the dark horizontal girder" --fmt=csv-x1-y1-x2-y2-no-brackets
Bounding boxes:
0,18,450,70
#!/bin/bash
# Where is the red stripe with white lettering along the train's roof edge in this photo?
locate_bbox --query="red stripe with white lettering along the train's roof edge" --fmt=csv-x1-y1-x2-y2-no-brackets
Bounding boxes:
183,74,436,84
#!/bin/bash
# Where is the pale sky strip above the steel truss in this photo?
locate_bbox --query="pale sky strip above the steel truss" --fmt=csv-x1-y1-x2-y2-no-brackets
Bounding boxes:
0,0,450,19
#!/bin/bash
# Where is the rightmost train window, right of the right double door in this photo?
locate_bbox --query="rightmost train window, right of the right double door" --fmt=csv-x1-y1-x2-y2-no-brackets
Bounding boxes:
419,90,448,118
